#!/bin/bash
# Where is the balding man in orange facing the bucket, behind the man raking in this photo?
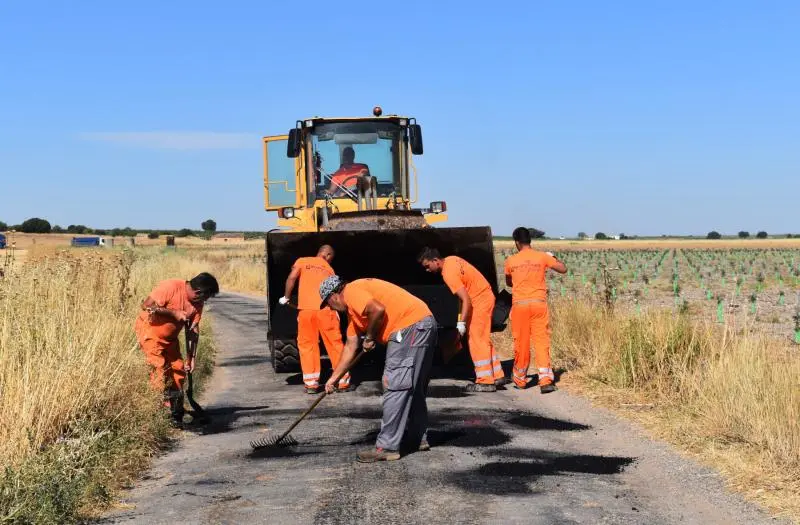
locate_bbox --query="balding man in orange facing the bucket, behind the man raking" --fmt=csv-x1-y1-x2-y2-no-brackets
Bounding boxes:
278,244,350,394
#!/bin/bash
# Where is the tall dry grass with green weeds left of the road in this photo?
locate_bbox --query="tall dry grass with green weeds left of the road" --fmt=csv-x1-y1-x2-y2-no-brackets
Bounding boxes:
0,249,216,523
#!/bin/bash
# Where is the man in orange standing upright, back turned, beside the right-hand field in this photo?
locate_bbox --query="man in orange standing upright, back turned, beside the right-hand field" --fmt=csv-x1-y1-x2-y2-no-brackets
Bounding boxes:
504,227,567,394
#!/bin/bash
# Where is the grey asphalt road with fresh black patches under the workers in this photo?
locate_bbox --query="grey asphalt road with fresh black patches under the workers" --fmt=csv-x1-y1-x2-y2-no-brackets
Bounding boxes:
101,294,776,525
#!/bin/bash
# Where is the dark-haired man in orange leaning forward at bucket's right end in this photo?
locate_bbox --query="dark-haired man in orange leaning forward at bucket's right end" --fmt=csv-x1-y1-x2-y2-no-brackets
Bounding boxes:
418,248,506,392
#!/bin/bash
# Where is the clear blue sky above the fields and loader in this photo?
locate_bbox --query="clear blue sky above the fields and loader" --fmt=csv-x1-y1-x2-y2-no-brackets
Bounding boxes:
0,0,800,235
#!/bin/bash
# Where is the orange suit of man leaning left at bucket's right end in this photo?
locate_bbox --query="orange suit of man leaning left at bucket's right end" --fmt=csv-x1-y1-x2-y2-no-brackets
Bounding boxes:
442,255,505,385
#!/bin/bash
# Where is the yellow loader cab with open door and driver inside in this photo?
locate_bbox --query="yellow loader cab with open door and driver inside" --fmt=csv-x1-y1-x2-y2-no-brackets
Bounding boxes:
264,107,446,231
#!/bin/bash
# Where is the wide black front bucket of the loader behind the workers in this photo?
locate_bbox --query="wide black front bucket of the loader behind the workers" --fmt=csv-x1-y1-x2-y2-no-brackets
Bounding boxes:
266,227,497,352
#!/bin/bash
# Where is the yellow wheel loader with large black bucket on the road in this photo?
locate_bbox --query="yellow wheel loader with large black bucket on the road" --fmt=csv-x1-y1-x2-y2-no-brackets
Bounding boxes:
263,107,503,372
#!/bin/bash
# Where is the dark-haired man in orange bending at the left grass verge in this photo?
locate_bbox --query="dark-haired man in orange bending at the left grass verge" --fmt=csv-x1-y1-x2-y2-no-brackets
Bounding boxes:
134,272,219,424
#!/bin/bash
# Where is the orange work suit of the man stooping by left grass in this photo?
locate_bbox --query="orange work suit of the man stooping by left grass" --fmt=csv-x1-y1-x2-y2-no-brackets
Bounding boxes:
134,279,203,391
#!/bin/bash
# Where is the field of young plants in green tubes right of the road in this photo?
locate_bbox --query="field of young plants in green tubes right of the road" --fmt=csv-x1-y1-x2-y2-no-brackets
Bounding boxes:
498,249,800,344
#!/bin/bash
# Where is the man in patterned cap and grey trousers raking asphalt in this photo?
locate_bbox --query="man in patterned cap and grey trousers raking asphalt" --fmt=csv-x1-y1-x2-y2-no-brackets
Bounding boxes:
319,276,437,463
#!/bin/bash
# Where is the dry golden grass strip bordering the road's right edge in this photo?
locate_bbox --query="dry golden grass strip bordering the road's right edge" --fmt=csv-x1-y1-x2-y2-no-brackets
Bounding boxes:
553,301,800,519
